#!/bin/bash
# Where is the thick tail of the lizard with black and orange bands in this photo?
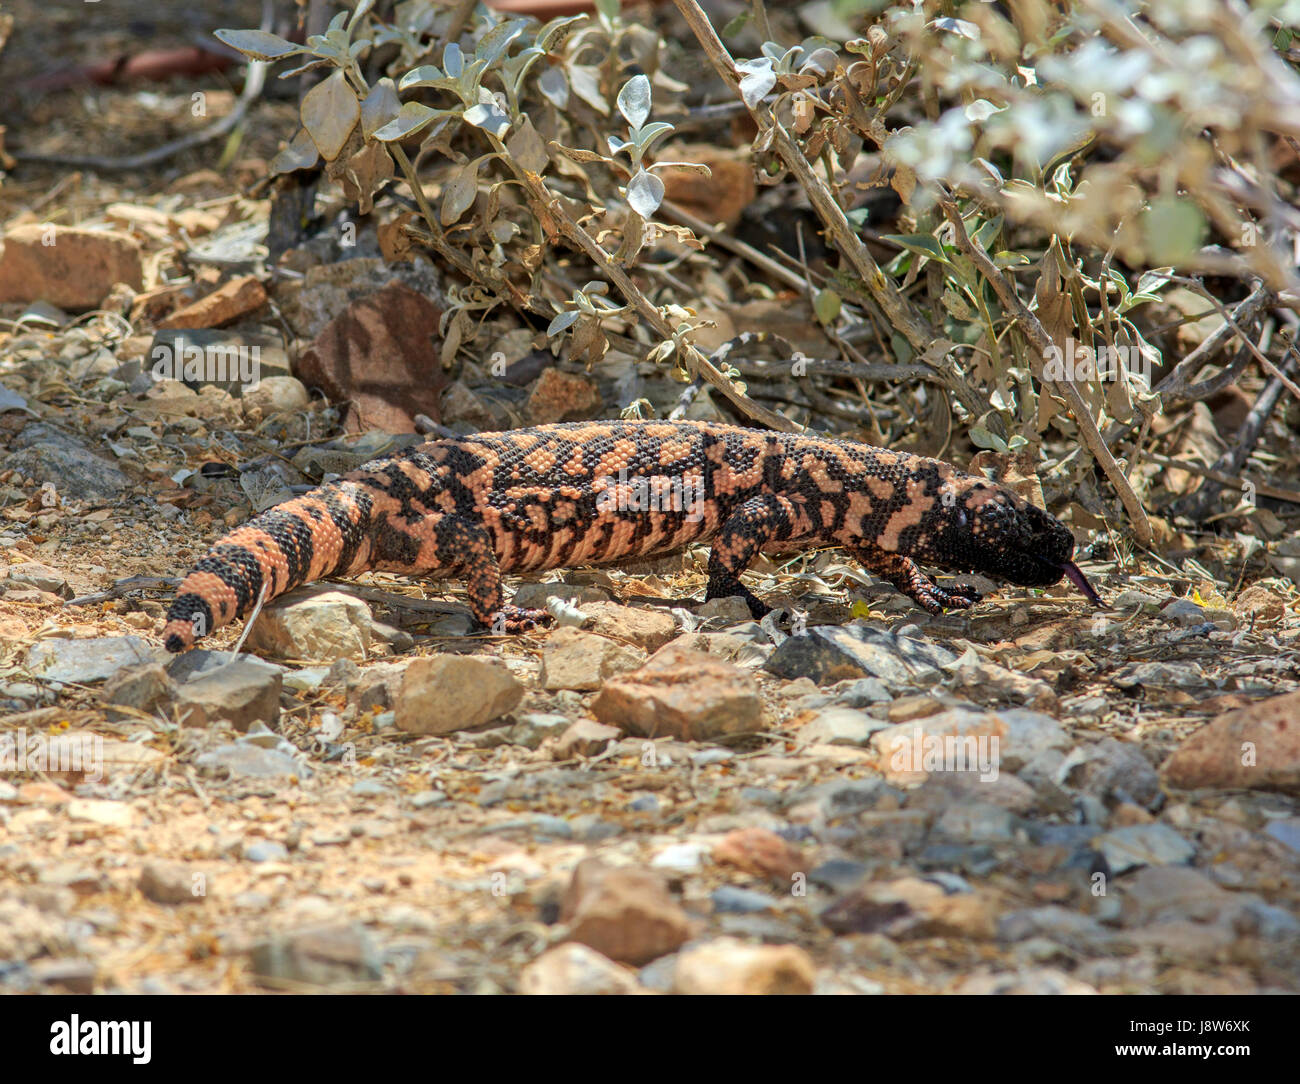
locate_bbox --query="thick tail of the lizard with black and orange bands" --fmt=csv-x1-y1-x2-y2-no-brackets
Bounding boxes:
163,477,374,652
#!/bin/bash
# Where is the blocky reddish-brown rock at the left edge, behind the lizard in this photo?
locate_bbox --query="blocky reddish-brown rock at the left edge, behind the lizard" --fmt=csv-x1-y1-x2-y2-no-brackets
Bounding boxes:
0,224,144,312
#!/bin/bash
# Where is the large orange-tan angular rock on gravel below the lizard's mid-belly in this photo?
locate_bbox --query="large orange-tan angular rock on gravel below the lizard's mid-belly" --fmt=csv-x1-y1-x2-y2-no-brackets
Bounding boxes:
592,647,764,741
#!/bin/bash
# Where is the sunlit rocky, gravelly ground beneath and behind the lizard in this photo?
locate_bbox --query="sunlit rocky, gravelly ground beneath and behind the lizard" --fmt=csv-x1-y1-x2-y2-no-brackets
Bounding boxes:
0,4,1300,993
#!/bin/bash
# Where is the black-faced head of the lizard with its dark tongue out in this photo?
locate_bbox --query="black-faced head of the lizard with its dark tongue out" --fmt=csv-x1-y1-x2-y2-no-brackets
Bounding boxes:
920,474,1101,606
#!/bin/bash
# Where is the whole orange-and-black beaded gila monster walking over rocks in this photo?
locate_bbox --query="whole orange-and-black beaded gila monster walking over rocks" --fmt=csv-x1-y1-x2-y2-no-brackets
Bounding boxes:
163,421,1100,651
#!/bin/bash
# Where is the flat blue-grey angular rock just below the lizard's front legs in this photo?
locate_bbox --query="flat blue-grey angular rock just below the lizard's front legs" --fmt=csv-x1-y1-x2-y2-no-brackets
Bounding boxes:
763,625,957,690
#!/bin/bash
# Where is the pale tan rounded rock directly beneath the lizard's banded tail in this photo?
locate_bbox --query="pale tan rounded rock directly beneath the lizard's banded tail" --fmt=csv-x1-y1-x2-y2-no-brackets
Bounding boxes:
247,590,373,660
